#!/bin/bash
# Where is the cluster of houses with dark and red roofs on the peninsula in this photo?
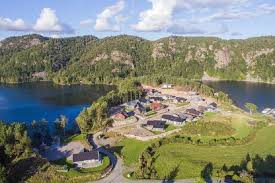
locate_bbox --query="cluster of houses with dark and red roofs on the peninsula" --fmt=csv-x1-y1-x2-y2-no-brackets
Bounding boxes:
109,84,220,131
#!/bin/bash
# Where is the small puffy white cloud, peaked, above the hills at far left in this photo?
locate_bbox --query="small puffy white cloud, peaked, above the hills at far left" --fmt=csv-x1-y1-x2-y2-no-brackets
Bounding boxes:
33,8,73,33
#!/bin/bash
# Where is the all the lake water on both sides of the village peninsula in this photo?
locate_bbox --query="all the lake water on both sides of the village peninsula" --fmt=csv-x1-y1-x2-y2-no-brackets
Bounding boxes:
0,82,275,123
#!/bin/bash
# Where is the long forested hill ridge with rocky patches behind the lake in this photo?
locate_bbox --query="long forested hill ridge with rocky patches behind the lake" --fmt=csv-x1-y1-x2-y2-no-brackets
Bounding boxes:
0,34,275,84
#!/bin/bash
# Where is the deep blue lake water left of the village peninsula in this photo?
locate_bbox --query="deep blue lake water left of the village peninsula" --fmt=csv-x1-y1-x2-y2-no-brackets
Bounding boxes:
0,82,112,123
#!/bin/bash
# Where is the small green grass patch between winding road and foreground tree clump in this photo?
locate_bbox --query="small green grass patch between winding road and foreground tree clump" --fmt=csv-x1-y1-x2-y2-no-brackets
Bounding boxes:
116,138,152,166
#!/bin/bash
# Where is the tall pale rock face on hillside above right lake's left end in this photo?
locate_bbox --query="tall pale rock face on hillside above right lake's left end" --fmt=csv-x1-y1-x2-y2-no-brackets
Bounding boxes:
214,47,230,69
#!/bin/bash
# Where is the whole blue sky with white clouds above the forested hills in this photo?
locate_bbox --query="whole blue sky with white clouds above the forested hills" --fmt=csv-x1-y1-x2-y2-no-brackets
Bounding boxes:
0,0,275,40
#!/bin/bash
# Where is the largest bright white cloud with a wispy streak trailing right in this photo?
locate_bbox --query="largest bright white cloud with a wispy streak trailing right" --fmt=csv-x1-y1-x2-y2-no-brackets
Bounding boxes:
132,0,245,34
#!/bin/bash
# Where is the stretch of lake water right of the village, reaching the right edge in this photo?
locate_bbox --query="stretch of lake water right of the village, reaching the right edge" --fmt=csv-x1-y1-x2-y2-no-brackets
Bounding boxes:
204,81,275,111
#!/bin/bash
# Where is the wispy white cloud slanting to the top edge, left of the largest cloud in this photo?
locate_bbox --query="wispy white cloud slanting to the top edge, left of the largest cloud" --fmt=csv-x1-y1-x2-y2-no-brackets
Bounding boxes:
94,1,125,32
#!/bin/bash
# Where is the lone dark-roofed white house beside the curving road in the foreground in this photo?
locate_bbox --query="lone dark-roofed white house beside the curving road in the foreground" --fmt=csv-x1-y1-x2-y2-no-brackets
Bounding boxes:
73,150,102,168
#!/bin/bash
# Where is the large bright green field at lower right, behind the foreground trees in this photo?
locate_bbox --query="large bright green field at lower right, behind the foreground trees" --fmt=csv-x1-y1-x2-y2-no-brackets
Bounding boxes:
155,127,275,178
